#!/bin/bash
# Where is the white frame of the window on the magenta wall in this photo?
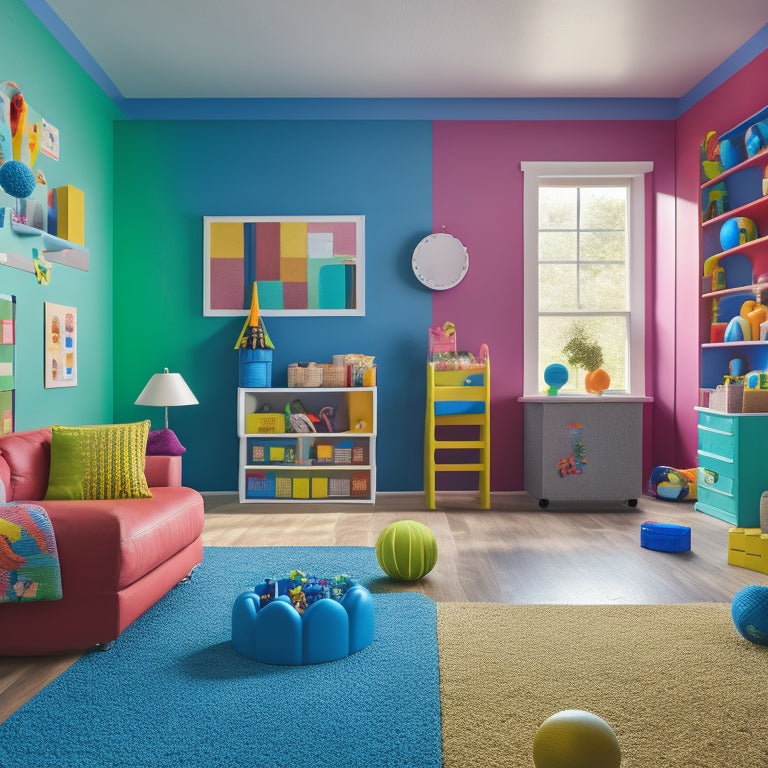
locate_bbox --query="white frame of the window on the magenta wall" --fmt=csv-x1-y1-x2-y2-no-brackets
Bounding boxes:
520,162,653,397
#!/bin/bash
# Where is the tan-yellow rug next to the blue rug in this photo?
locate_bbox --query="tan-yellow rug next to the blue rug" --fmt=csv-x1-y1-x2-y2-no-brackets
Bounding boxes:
437,603,768,768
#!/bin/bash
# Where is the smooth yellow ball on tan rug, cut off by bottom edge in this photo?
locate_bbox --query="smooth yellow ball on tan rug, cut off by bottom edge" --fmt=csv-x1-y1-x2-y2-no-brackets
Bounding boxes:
533,709,621,768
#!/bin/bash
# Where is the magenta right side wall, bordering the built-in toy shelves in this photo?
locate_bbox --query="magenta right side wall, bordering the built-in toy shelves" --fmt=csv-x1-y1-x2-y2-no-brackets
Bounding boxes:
674,50,768,466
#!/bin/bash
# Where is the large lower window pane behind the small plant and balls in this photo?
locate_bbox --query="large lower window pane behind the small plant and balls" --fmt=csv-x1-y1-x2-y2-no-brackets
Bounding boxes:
538,316,627,394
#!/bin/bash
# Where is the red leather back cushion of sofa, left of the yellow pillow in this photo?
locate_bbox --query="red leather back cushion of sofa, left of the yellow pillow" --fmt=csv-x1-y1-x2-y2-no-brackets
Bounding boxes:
0,427,51,501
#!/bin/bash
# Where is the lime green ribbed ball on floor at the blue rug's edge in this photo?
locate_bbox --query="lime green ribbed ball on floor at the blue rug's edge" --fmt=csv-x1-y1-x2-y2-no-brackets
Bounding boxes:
376,520,437,581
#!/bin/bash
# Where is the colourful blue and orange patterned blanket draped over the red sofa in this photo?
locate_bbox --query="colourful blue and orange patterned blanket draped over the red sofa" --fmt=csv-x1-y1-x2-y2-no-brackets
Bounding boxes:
0,503,62,603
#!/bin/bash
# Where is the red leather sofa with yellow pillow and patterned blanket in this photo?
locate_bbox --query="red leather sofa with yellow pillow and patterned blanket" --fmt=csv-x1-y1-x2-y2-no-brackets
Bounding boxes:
0,429,204,656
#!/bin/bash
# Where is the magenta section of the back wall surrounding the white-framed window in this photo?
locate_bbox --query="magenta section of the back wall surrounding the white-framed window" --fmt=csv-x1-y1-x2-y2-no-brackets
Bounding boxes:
432,121,680,491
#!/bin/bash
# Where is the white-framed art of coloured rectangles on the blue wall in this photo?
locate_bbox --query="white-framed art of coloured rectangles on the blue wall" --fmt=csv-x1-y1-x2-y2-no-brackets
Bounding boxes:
203,216,365,316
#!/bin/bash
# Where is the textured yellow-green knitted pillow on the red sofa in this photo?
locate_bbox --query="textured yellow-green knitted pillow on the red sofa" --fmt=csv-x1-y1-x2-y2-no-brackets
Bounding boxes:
45,421,152,499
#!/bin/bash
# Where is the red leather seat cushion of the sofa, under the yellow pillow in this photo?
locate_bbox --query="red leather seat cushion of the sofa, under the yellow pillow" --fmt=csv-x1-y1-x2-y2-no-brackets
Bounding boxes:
41,487,205,598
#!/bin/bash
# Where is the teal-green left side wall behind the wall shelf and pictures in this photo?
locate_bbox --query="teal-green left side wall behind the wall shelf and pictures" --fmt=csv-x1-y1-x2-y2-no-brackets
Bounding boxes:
0,0,118,430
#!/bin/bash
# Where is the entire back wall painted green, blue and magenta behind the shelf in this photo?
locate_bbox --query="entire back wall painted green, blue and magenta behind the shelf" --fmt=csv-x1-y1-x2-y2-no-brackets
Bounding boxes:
115,121,674,491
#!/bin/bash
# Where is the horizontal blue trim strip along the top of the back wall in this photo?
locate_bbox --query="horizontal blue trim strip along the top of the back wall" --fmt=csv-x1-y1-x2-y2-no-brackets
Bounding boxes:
117,99,677,120
